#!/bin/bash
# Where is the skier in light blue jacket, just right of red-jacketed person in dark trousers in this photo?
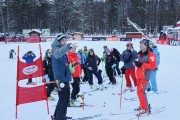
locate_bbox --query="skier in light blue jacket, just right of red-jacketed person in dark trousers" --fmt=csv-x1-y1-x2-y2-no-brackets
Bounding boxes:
77,49,88,82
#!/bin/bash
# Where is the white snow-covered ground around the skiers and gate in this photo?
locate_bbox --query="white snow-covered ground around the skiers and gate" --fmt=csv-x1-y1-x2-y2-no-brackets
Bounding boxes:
0,40,180,120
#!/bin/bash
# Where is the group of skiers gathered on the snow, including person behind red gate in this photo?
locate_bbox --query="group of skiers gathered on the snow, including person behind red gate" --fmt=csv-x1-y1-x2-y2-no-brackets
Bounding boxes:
19,34,160,120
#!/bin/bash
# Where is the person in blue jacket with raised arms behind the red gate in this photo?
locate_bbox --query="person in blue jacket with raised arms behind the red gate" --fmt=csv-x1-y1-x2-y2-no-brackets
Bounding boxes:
22,51,36,85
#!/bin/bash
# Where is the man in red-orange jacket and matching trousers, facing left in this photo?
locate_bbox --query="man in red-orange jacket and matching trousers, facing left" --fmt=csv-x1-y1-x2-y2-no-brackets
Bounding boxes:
133,39,156,115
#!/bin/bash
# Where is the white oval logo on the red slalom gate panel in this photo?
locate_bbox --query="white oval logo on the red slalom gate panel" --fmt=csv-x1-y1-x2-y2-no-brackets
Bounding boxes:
23,65,38,75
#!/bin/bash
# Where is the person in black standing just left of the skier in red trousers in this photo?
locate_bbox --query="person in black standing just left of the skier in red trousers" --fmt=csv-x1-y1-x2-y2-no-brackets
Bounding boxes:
111,48,121,76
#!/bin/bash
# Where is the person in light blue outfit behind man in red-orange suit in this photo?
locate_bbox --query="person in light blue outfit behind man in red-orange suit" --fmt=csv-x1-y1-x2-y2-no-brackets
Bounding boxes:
146,41,160,93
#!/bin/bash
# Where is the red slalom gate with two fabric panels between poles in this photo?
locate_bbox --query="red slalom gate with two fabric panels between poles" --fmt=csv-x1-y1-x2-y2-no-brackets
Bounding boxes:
16,45,49,119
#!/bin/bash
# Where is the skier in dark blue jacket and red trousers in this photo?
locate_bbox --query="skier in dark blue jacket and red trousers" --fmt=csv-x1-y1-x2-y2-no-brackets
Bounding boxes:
121,43,137,92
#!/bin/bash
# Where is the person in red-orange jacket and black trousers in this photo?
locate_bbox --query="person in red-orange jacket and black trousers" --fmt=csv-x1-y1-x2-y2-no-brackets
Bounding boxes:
67,48,82,101
